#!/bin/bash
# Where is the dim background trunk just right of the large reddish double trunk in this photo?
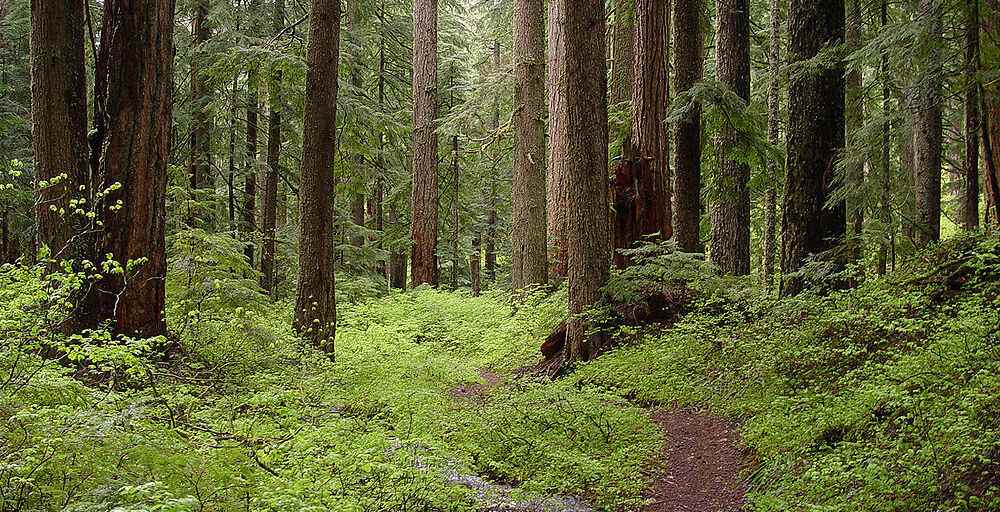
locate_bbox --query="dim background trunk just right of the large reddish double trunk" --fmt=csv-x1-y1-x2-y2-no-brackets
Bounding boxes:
188,0,212,198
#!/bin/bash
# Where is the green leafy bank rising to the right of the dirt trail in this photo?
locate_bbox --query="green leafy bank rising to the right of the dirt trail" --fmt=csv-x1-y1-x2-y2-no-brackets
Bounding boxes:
570,237,1000,511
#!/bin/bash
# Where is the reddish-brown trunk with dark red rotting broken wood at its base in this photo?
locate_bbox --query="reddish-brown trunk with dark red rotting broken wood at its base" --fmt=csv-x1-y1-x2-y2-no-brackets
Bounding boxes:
614,0,673,266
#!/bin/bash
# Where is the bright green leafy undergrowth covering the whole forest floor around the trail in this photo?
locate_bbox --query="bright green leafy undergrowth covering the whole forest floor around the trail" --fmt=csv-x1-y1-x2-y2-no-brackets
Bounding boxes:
0,236,1000,512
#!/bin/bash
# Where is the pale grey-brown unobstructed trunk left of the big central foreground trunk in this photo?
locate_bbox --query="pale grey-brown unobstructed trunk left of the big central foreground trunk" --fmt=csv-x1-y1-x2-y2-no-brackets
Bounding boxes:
511,0,548,289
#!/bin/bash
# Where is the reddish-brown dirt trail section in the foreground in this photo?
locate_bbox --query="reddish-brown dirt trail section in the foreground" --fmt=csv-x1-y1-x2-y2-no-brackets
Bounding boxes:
643,408,747,512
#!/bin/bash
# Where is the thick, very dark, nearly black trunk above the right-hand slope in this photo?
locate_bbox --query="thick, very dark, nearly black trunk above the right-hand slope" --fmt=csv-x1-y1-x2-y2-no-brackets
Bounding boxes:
781,0,847,295
